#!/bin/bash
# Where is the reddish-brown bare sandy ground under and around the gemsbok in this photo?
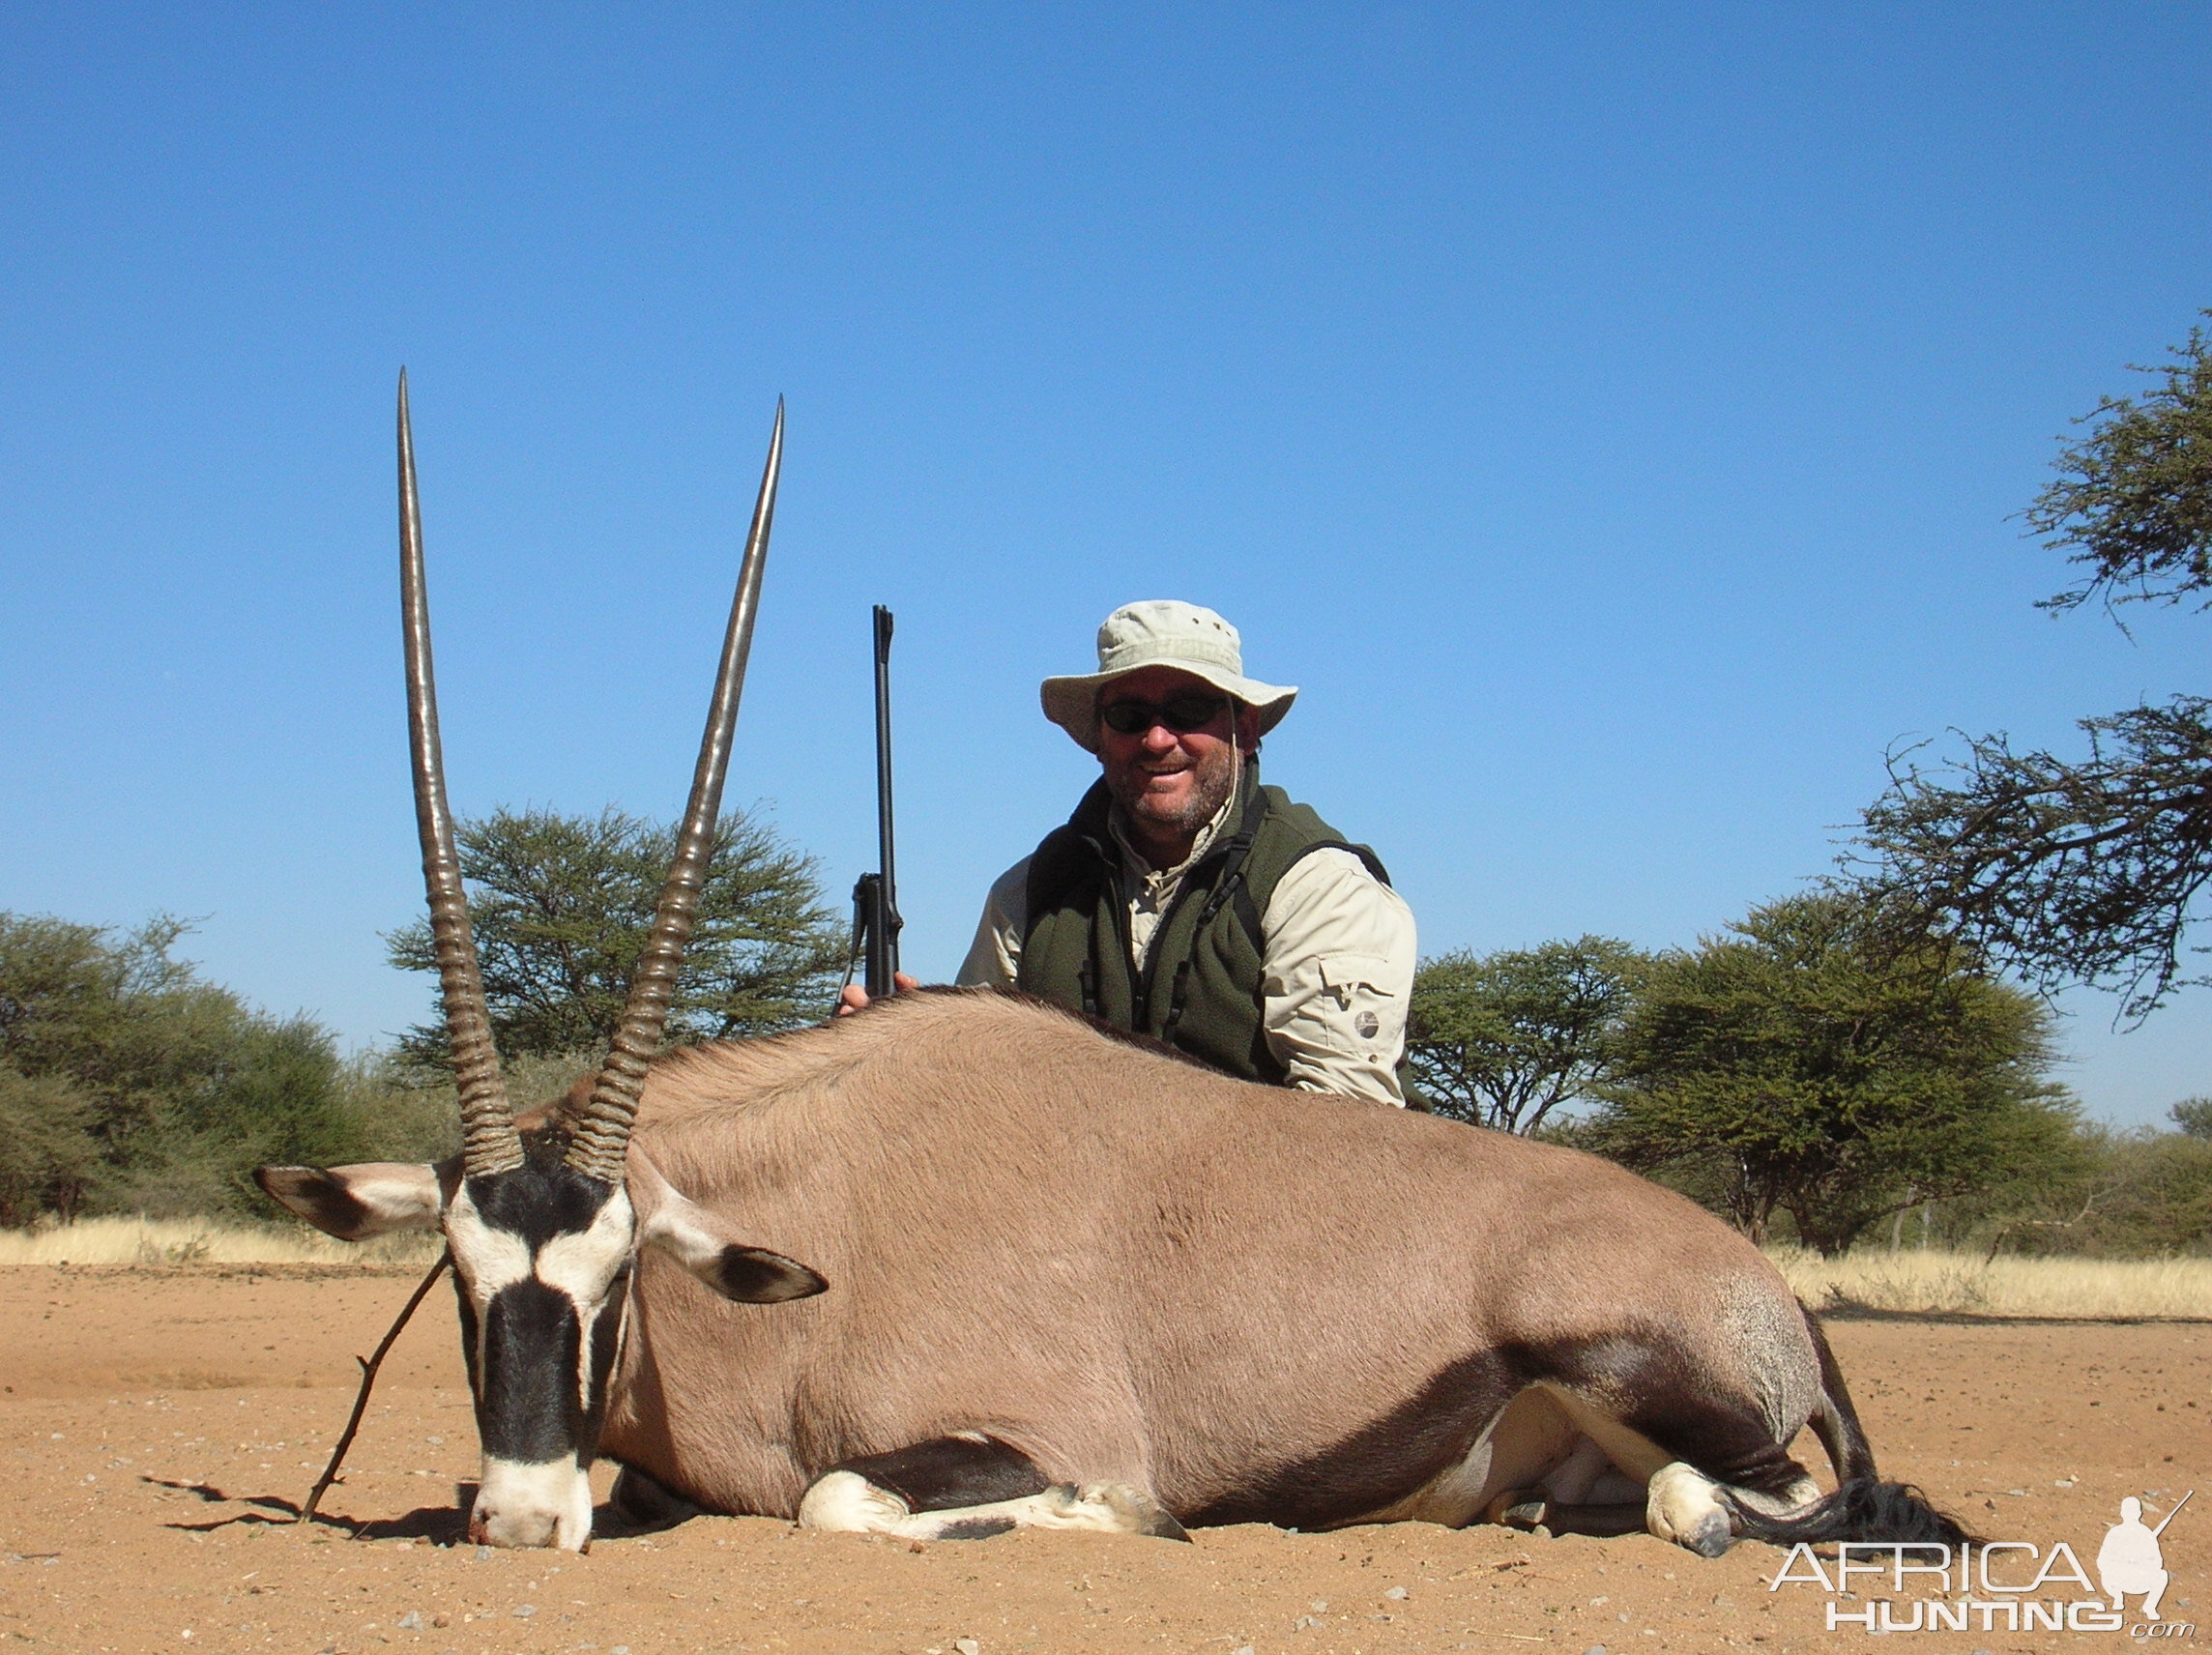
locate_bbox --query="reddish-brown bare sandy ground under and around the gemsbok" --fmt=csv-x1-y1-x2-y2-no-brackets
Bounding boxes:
0,1267,2212,1655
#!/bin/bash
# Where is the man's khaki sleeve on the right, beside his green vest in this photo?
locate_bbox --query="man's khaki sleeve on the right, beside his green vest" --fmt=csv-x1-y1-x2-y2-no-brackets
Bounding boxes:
1261,850,1418,1109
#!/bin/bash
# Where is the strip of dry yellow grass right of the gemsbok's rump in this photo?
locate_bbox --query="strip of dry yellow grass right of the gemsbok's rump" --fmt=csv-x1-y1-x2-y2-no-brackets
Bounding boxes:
1772,1248,2212,1319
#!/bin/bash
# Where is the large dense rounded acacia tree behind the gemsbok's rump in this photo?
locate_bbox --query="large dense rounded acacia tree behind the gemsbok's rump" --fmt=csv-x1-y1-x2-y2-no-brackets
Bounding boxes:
1582,887,2071,1252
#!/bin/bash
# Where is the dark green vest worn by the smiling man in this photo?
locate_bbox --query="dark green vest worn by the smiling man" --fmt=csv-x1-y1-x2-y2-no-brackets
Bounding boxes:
1017,772,1412,1097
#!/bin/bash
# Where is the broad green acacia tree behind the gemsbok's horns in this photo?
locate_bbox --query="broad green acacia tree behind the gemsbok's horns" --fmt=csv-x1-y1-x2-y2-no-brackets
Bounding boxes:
385,810,845,1066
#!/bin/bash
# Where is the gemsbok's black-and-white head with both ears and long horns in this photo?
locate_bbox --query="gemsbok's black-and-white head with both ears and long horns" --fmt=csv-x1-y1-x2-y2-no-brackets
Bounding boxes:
254,374,825,1551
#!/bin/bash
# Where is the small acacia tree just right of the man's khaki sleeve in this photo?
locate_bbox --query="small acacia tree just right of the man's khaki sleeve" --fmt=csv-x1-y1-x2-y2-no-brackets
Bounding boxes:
1407,936,1645,1133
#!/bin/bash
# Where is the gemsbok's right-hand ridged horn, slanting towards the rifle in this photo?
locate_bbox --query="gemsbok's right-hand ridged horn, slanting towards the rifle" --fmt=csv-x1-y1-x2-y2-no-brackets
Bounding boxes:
568,396,783,1183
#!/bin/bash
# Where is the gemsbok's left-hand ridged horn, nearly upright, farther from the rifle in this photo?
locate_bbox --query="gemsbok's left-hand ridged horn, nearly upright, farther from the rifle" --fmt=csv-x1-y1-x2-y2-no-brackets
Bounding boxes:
400,367,522,1177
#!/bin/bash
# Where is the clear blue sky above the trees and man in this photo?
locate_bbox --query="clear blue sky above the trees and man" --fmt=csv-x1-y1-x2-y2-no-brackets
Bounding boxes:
0,5,2212,1121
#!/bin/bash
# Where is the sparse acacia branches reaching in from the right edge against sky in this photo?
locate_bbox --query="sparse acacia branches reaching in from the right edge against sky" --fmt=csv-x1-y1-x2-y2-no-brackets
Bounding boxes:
1860,312,2212,1020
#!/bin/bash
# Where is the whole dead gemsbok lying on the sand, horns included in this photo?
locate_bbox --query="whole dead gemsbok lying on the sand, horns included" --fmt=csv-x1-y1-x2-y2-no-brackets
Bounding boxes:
259,376,1960,1555
